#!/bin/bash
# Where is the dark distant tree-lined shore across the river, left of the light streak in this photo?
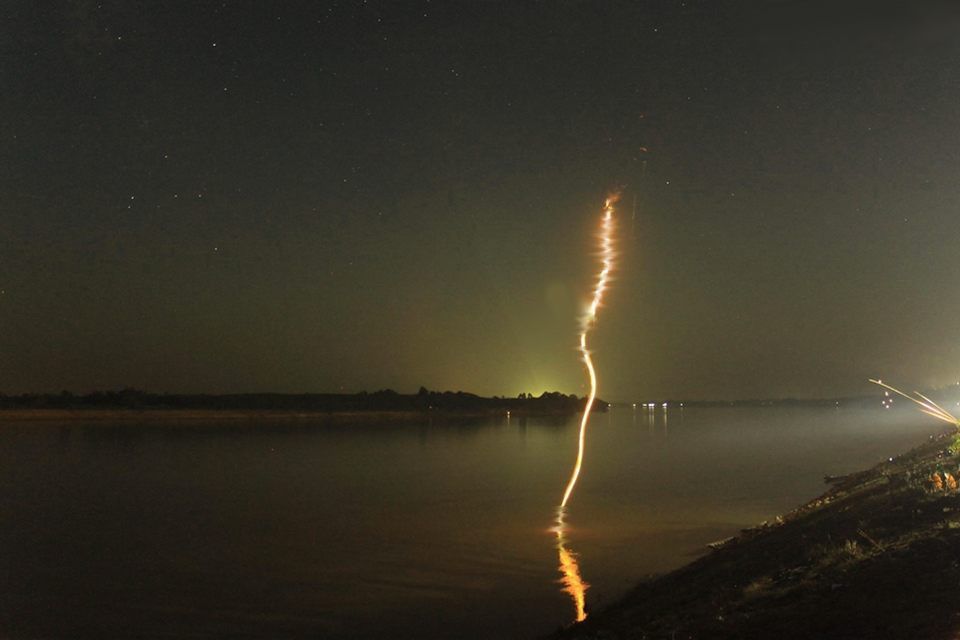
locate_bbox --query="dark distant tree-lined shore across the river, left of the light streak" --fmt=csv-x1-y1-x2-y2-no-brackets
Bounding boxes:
0,387,608,415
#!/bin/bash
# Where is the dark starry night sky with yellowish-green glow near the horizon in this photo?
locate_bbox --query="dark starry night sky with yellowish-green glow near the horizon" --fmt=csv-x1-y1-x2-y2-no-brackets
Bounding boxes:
0,0,960,400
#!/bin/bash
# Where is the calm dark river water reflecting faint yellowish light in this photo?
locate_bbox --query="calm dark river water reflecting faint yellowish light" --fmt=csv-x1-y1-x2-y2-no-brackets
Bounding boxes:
0,406,941,638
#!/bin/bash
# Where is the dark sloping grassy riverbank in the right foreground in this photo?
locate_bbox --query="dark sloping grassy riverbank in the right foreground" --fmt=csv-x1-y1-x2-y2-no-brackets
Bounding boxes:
553,436,960,640
